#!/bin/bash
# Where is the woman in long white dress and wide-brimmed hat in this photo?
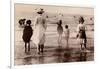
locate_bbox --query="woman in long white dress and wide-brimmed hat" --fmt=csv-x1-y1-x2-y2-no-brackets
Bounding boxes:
32,9,47,54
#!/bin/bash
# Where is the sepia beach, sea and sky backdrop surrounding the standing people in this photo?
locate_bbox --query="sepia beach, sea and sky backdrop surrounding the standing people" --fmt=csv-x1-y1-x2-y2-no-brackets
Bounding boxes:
14,3,94,65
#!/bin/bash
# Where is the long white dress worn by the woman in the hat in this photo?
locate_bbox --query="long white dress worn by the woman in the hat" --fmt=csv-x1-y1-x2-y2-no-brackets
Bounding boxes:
32,16,46,46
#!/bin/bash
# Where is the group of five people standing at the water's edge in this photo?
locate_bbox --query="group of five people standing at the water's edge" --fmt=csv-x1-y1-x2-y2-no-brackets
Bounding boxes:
20,9,87,54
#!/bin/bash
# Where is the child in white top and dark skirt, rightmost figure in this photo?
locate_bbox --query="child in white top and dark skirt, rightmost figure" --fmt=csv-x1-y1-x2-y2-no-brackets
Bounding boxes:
77,17,87,50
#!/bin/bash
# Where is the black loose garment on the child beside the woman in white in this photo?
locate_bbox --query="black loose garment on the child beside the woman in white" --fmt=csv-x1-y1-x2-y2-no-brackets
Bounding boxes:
22,26,33,42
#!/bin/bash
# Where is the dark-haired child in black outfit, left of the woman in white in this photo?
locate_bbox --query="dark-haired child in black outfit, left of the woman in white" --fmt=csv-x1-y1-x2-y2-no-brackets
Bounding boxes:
22,20,33,53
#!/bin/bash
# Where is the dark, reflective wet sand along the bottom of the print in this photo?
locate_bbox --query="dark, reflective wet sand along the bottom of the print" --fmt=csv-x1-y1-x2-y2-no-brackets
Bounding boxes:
15,43,94,65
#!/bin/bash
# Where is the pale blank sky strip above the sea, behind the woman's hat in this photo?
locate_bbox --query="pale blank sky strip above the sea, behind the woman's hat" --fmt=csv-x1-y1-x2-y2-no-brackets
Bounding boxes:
15,4,94,15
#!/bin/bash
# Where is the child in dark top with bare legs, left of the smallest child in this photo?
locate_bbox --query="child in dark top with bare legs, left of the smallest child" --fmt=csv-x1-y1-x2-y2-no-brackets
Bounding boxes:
57,20,63,46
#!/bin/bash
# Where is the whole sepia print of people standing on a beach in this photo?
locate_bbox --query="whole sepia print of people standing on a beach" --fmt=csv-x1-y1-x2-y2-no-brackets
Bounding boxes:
14,3,94,65
